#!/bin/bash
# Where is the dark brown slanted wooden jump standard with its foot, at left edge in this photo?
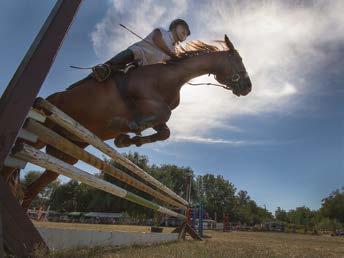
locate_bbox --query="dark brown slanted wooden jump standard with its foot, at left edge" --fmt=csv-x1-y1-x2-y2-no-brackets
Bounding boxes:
0,0,82,257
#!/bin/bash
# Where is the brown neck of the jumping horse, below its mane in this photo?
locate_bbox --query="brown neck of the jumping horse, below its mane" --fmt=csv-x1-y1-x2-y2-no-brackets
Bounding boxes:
175,52,224,84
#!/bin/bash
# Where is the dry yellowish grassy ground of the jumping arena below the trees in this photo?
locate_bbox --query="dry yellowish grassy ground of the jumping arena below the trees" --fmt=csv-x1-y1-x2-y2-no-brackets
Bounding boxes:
33,223,344,258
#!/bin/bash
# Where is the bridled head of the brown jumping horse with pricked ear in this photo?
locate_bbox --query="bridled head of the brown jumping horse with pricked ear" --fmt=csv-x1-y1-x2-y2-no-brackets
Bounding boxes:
215,35,252,96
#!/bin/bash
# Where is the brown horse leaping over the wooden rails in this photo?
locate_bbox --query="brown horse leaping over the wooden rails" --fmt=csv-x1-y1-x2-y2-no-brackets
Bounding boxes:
2,36,251,208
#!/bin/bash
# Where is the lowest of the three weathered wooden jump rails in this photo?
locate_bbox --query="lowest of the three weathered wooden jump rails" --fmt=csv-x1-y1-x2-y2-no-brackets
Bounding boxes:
14,143,185,219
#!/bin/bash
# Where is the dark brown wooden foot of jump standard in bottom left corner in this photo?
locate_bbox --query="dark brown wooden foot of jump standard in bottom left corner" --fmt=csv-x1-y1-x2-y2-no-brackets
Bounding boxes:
0,176,47,257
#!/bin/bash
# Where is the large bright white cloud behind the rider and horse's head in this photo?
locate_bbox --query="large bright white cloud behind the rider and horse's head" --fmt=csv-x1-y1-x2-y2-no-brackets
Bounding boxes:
92,0,344,143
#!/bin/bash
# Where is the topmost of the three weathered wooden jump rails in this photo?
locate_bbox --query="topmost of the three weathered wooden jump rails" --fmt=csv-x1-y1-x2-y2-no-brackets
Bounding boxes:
34,98,188,206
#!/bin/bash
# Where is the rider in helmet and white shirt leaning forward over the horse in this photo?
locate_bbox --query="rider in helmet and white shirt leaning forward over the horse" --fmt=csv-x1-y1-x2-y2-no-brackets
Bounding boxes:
92,19,190,82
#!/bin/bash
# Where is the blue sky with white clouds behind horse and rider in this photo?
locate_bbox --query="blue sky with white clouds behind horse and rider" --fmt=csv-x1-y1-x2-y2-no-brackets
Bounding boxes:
0,0,344,212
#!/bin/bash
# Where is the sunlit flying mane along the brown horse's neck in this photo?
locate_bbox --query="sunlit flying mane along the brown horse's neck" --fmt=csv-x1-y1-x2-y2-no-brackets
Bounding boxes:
174,40,229,61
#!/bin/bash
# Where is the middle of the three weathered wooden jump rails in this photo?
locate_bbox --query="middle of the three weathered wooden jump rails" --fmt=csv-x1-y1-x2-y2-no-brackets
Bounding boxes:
24,119,186,209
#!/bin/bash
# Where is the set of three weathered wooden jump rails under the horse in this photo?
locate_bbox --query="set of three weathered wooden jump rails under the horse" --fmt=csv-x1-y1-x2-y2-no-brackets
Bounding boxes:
10,98,189,219
